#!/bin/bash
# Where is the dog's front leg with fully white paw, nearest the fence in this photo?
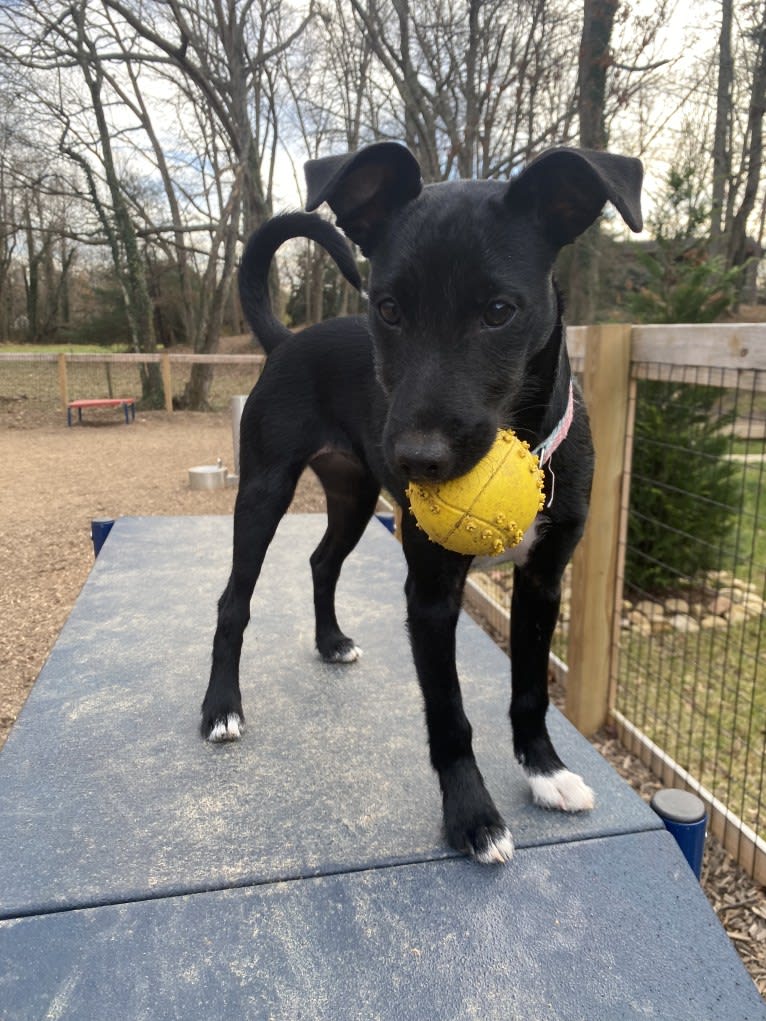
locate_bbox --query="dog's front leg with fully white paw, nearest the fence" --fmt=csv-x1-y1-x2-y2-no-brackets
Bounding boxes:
511,534,594,812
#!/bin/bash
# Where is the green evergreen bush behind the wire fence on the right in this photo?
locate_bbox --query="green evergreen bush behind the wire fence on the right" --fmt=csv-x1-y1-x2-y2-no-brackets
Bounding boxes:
625,157,740,594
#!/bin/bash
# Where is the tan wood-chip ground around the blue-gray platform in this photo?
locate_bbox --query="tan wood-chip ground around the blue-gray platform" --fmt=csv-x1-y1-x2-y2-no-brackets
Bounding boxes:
0,401,766,995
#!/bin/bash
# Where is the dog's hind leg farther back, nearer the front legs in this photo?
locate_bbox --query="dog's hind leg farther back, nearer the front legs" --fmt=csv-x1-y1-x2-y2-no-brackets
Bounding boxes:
310,451,380,663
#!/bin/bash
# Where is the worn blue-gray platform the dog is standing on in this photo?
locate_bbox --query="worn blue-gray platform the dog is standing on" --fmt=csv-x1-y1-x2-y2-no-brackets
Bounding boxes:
0,516,766,1019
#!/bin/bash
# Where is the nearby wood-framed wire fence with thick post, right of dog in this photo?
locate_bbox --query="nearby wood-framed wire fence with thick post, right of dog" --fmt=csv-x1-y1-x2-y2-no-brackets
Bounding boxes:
467,325,766,882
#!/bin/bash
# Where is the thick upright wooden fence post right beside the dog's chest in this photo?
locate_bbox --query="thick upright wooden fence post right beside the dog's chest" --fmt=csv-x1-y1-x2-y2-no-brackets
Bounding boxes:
565,325,631,736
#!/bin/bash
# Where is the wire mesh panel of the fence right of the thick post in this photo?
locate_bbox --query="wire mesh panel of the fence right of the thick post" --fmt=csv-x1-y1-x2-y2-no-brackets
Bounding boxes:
614,363,766,874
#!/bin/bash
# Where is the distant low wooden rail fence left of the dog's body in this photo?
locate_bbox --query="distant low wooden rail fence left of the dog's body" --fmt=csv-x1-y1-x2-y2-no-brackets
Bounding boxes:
0,352,265,411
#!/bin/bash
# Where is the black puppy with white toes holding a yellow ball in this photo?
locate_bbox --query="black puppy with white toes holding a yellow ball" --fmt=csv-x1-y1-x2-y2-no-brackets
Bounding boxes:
202,143,641,862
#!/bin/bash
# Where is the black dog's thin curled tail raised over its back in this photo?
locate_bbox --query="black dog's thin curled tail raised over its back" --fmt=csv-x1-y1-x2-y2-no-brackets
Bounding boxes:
239,212,362,354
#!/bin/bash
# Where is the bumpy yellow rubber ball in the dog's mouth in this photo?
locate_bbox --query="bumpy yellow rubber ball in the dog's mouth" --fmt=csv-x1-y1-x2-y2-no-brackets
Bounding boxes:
406,429,545,556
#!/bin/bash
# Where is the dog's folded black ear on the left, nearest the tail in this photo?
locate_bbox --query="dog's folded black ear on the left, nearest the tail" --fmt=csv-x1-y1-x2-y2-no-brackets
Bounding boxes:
304,142,423,255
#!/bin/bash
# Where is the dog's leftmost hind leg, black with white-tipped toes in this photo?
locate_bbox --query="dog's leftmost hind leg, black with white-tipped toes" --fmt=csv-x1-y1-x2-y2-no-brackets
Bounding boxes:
200,469,298,741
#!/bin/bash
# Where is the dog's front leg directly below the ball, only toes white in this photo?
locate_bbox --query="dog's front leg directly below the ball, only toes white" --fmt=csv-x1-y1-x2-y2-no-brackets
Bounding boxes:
402,514,514,864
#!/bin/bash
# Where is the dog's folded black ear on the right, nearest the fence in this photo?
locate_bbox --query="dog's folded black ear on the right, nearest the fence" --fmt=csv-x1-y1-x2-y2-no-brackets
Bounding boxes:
507,148,643,248
